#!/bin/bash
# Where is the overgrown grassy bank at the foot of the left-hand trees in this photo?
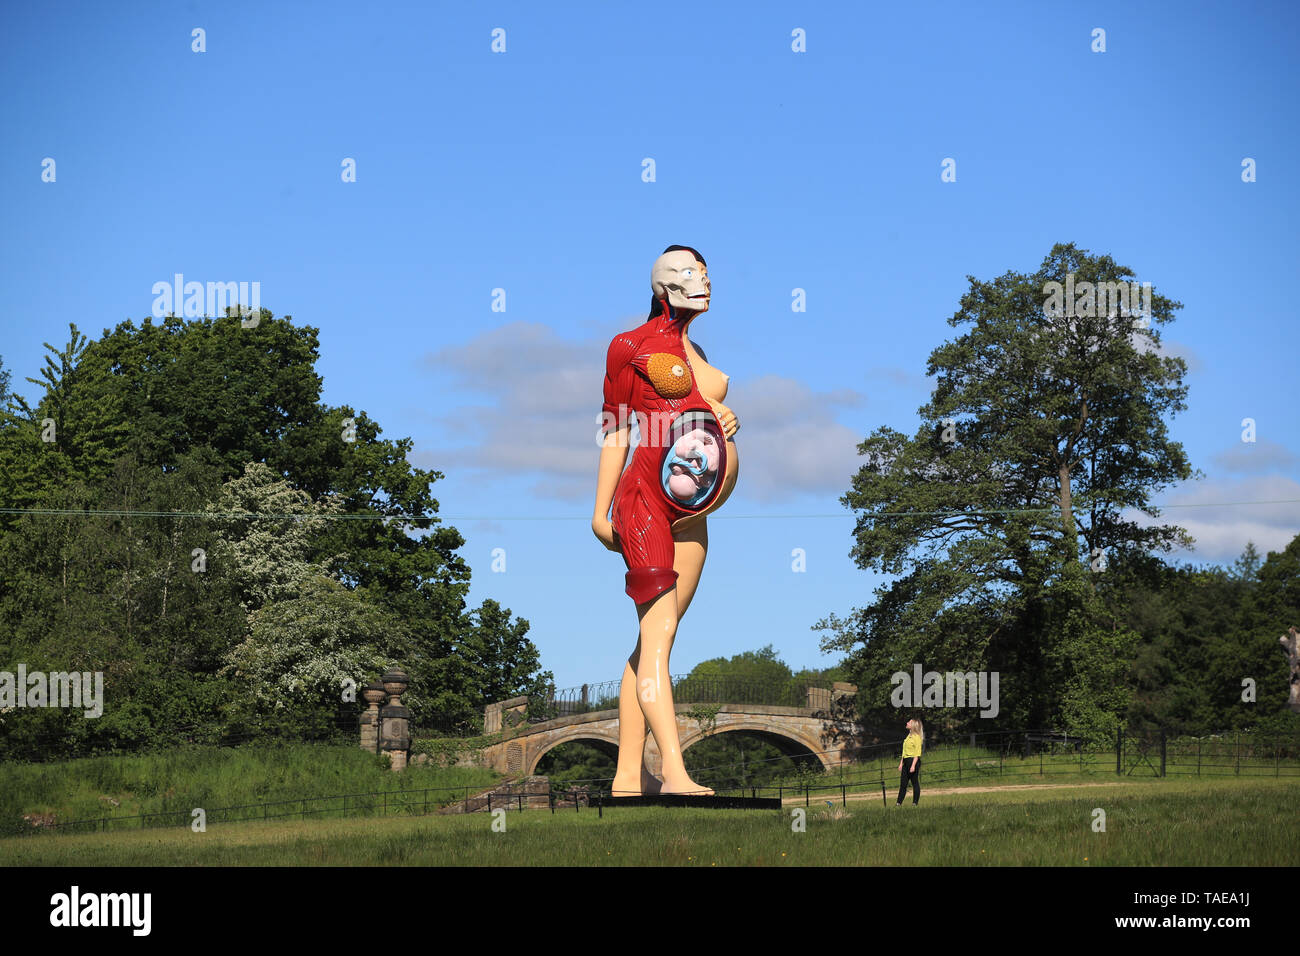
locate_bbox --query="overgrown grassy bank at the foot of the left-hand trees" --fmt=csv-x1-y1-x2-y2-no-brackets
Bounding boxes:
0,744,499,832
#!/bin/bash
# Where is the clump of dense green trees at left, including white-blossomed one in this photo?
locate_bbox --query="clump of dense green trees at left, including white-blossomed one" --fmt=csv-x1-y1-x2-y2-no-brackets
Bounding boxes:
0,310,546,753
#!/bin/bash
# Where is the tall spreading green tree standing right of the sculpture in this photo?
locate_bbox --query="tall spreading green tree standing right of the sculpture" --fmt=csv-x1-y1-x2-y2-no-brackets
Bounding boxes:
815,245,1193,727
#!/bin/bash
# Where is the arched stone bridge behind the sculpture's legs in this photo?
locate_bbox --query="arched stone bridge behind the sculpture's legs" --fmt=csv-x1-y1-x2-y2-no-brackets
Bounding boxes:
484,683,858,777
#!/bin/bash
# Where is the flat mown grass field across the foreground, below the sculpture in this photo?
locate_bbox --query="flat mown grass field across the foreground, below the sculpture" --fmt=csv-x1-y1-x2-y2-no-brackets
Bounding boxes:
0,778,1300,866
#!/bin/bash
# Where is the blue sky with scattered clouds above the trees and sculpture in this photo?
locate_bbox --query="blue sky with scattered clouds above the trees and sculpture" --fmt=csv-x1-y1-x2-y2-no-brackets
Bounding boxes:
0,3,1300,687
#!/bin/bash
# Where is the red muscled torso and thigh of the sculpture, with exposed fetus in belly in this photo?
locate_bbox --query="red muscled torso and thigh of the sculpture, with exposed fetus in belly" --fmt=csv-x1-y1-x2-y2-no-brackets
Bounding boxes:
602,315,728,604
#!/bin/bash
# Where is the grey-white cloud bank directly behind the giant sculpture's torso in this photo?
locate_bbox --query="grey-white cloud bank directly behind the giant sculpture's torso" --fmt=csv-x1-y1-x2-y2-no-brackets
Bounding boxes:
411,319,865,502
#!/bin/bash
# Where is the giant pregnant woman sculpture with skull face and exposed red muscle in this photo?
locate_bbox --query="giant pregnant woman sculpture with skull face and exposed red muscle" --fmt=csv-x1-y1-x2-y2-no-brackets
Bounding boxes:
592,246,738,796
